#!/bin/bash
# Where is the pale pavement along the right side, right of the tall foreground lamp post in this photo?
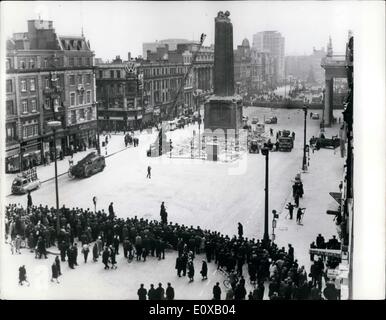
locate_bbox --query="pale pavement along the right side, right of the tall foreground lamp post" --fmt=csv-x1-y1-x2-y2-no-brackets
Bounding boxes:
269,126,344,272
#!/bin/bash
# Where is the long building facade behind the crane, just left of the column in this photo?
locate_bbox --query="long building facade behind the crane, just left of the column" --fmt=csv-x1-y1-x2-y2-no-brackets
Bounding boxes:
140,41,214,121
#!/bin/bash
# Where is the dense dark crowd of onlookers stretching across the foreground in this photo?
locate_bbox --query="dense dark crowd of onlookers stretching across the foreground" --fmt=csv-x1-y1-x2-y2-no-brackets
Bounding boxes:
5,195,340,300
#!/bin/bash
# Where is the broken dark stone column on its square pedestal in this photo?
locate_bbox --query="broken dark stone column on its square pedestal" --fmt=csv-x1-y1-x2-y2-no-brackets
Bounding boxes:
204,11,243,149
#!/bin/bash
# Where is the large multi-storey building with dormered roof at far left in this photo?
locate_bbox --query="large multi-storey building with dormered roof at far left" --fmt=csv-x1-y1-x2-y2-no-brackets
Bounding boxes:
6,20,96,172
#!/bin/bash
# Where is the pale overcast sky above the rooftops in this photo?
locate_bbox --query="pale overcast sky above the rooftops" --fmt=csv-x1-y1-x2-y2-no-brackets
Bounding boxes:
2,1,374,59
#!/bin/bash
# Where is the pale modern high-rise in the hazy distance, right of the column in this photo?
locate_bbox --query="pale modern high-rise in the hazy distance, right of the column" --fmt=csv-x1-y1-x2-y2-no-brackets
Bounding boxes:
252,31,285,84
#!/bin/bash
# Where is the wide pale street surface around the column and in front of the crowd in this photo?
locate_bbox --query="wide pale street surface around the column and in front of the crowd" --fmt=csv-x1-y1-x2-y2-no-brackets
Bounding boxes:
3,107,343,299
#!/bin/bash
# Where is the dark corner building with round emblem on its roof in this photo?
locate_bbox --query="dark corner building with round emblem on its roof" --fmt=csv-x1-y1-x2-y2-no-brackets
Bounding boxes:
96,56,144,131
